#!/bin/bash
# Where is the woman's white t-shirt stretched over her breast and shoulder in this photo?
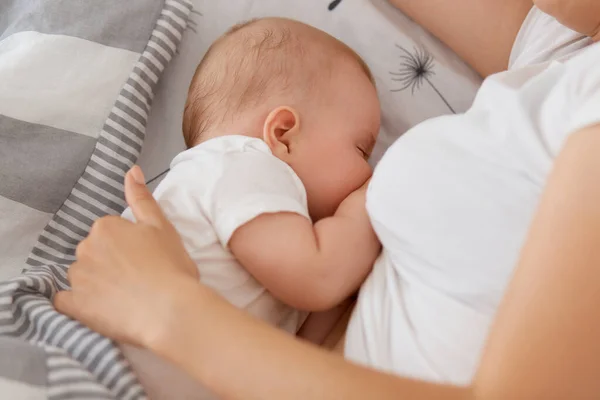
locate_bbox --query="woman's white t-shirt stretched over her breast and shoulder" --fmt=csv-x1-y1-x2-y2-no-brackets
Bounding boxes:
345,9,600,384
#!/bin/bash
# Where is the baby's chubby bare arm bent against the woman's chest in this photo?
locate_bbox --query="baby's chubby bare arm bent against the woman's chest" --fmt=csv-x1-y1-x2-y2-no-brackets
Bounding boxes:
229,187,380,311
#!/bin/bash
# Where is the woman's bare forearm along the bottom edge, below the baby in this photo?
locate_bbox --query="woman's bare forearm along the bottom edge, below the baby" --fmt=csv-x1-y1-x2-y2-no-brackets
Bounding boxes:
147,285,469,400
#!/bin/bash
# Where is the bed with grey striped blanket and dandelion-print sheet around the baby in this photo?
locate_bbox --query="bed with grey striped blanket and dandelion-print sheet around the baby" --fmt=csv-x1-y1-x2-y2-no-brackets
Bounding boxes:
0,0,481,399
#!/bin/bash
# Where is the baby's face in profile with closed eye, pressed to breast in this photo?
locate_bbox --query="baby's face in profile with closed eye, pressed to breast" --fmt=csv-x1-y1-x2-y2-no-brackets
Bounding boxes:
290,61,381,220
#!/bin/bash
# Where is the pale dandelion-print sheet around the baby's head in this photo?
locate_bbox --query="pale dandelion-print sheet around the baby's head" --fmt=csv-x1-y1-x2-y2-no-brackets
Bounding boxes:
139,0,481,192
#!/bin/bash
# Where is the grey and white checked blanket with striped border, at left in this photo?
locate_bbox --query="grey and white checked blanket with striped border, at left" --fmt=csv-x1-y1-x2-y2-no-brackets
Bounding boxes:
0,0,191,399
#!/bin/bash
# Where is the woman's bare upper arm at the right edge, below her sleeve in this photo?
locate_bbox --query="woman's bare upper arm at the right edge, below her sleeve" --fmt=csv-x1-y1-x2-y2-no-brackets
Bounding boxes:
475,126,600,399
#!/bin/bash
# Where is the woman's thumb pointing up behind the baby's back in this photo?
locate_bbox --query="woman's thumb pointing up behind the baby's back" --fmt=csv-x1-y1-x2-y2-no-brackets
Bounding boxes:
125,165,167,227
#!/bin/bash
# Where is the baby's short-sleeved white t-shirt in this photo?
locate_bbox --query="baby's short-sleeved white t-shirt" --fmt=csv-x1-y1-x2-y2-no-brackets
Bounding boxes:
123,135,310,333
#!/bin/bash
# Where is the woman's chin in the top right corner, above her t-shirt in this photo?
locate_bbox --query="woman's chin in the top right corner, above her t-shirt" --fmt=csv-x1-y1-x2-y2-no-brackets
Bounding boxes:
534,0,600,40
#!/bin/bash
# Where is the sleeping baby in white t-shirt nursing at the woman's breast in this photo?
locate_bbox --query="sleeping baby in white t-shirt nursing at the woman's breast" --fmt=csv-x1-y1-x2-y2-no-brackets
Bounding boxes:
123,18,380,398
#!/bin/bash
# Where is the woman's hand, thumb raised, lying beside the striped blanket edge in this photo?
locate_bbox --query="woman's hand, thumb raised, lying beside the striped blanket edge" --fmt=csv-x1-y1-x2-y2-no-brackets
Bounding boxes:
54,166,198,346
